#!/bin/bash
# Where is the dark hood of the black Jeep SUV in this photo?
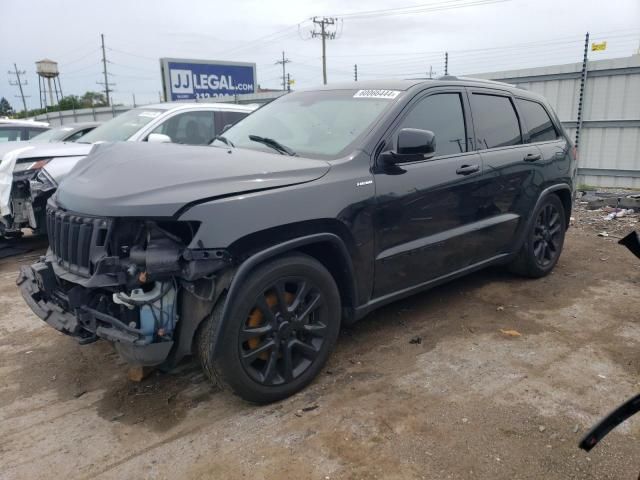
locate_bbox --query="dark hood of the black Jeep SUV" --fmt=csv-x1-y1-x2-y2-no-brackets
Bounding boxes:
56,142,330,217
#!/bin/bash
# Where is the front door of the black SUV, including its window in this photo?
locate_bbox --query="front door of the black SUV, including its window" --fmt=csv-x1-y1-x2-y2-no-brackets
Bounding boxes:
373,89,487,297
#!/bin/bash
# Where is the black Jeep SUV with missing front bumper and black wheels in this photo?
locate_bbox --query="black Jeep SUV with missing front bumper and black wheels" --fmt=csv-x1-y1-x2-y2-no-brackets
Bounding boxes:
18,77,576,402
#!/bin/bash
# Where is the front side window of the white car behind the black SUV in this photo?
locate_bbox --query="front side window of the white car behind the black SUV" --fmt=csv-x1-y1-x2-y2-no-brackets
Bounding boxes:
151,111,216,145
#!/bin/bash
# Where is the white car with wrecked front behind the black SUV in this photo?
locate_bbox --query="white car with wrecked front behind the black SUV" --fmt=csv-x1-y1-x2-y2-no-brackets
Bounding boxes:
0,103,258,237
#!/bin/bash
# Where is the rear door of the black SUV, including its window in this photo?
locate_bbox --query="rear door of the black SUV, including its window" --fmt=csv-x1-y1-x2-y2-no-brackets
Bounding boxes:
468,88,542,257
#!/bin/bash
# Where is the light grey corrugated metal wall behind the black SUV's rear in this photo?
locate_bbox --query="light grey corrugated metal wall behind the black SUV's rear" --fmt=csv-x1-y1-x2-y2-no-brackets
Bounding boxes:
472,55,640,188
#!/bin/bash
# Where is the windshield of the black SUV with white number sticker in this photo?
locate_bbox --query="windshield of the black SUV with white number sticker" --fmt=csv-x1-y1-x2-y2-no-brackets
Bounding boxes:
223,90,399,158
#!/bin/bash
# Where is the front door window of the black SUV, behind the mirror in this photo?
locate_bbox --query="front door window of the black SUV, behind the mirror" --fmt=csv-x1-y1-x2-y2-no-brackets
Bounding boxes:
400,93,467,156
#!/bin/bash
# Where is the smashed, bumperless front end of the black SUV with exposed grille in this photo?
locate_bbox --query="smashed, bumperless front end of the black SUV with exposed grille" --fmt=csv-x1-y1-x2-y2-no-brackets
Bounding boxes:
17,199,231,365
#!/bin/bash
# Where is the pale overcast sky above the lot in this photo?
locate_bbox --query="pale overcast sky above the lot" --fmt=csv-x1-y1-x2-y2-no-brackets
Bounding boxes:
0,0,640,109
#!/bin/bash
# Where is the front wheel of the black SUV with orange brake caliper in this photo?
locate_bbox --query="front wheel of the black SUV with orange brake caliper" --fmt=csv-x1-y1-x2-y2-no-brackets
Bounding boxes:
198,254,341,403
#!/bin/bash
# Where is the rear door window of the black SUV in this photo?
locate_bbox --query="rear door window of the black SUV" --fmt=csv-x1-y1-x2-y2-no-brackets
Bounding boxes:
471,93,522,150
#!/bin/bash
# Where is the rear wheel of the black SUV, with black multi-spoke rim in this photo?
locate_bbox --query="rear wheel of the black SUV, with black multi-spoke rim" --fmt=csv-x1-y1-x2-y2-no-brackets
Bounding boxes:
509,194,567,278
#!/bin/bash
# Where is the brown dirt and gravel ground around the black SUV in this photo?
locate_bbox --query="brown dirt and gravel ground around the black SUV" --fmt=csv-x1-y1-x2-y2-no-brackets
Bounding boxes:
0,203,640,480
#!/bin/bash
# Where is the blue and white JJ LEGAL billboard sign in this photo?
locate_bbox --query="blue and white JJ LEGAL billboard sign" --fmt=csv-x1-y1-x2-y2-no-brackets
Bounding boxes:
160,58,256,101
